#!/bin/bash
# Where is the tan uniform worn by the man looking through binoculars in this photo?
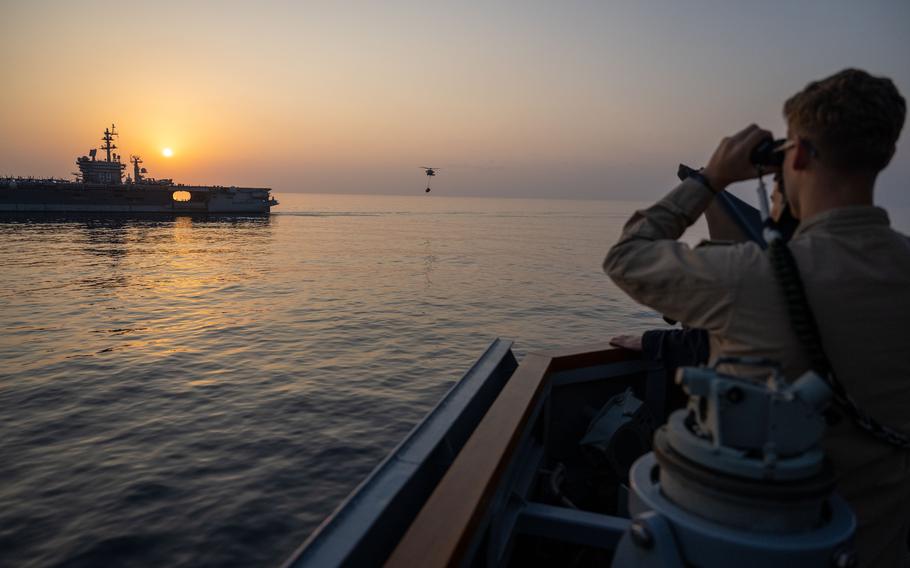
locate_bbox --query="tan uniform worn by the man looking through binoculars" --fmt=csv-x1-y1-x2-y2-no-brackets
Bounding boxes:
604,180,910,567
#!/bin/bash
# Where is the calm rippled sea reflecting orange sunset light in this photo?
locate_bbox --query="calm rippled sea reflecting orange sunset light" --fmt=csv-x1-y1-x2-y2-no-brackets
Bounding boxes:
0,194,907,566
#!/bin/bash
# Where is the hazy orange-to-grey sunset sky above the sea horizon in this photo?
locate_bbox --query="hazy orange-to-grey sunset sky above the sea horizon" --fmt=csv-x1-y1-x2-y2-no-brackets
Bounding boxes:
0,0,910,206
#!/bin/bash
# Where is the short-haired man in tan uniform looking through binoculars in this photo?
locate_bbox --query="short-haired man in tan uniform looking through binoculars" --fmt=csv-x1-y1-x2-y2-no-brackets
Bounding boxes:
604,69,910,567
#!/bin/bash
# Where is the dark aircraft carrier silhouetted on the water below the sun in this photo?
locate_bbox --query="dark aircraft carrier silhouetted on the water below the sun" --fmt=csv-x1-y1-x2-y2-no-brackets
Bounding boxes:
0,124,278,215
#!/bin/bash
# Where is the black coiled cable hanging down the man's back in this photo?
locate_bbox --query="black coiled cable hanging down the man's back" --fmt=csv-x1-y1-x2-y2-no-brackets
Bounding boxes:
768,238,910,449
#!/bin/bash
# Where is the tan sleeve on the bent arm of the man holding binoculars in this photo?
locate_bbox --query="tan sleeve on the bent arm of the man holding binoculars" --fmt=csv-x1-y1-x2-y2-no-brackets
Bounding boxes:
604,179,740,332
